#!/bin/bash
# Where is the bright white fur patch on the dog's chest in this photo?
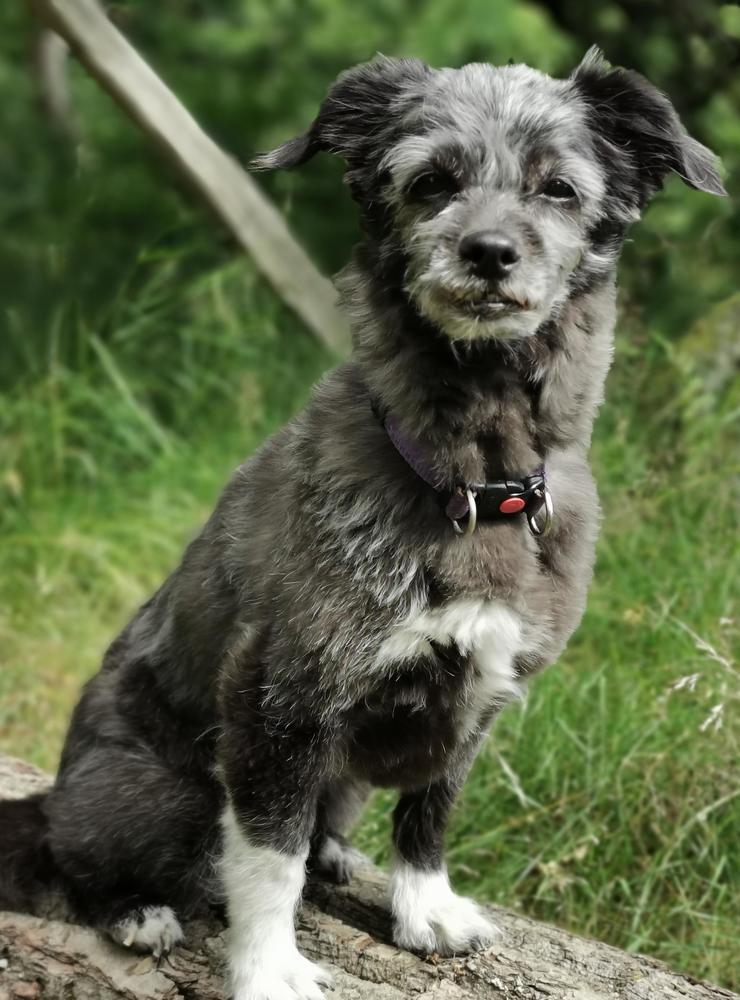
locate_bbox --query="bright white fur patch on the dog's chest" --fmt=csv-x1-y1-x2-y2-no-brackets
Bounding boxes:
376,597,524,732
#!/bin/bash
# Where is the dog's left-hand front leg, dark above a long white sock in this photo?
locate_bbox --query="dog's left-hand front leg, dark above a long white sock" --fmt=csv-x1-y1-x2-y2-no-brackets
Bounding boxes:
221,696,330,1000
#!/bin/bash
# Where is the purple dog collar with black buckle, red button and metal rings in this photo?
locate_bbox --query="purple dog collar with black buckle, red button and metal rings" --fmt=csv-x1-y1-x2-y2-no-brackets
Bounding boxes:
372,401,553,535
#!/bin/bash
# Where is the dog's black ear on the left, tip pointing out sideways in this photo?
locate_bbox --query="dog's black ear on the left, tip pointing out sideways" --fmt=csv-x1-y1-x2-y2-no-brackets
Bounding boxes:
252,56,431,170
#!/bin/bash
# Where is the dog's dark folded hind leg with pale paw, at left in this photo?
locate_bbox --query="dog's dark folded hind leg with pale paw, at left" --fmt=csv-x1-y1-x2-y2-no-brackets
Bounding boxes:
46,743,221,956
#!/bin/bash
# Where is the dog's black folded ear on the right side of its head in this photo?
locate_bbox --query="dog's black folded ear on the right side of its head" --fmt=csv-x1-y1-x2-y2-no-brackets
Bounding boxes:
571,46,727,202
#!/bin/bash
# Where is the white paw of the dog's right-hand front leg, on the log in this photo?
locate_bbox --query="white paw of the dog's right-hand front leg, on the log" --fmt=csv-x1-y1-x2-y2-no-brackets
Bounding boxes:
391,863,501,955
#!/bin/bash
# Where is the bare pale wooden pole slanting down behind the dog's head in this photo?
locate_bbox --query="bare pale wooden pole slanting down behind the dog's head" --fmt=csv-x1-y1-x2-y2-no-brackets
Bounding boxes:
27,0,349,353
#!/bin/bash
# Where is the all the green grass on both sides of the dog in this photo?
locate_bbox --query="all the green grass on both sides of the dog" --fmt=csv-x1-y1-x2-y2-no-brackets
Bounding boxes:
0,254,740,985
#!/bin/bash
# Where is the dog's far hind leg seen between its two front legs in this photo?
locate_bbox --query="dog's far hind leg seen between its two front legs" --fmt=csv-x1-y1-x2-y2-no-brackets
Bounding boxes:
308,778,370,885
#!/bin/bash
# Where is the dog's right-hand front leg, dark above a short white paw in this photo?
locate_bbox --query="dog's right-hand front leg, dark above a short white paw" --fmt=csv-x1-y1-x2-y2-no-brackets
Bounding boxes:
390,779,500,955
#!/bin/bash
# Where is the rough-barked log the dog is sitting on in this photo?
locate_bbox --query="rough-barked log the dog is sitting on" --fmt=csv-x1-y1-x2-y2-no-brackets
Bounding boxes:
0,756,740,1000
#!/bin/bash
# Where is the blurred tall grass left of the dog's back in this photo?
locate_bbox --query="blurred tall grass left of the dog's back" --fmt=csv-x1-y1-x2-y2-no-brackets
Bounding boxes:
0,257,328,767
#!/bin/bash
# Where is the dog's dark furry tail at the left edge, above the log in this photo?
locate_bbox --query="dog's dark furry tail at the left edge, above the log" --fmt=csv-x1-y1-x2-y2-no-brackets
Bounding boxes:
0,793,54,911
